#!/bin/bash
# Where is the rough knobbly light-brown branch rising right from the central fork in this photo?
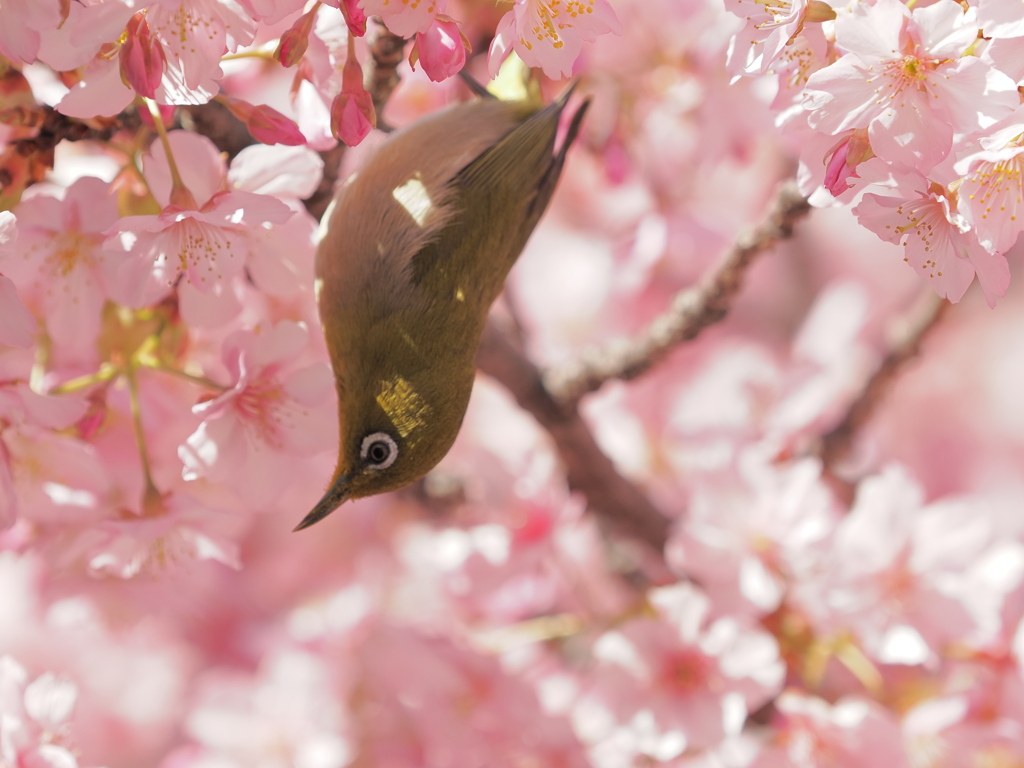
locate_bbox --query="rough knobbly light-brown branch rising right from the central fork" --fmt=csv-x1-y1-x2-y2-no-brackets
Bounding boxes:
544,181,810,404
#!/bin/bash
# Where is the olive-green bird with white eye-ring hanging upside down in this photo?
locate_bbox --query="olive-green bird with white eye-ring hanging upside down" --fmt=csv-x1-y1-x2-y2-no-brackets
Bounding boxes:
296,83,588,530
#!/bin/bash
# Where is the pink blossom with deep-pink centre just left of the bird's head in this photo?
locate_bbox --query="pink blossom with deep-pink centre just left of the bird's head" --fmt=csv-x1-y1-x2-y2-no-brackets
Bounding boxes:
178,322,334,505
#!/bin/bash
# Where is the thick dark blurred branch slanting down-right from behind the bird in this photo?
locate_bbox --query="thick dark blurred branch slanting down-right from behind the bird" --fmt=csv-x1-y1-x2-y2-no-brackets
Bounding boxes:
476,323,671,553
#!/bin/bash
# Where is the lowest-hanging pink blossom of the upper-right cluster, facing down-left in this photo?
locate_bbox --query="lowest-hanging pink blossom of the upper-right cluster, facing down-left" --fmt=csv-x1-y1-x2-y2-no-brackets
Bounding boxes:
854,162,1010,306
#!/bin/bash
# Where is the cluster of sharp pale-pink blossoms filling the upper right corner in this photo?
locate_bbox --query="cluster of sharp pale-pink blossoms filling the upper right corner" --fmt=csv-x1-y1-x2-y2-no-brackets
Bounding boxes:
726,0,1024,305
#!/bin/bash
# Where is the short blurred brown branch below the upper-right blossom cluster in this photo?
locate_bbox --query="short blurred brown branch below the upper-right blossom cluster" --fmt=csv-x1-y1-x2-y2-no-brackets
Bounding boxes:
812,288,950,475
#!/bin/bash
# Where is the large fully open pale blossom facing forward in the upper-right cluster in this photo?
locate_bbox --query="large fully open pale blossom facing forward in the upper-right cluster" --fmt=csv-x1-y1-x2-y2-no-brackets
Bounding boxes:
804,0,1018,172
